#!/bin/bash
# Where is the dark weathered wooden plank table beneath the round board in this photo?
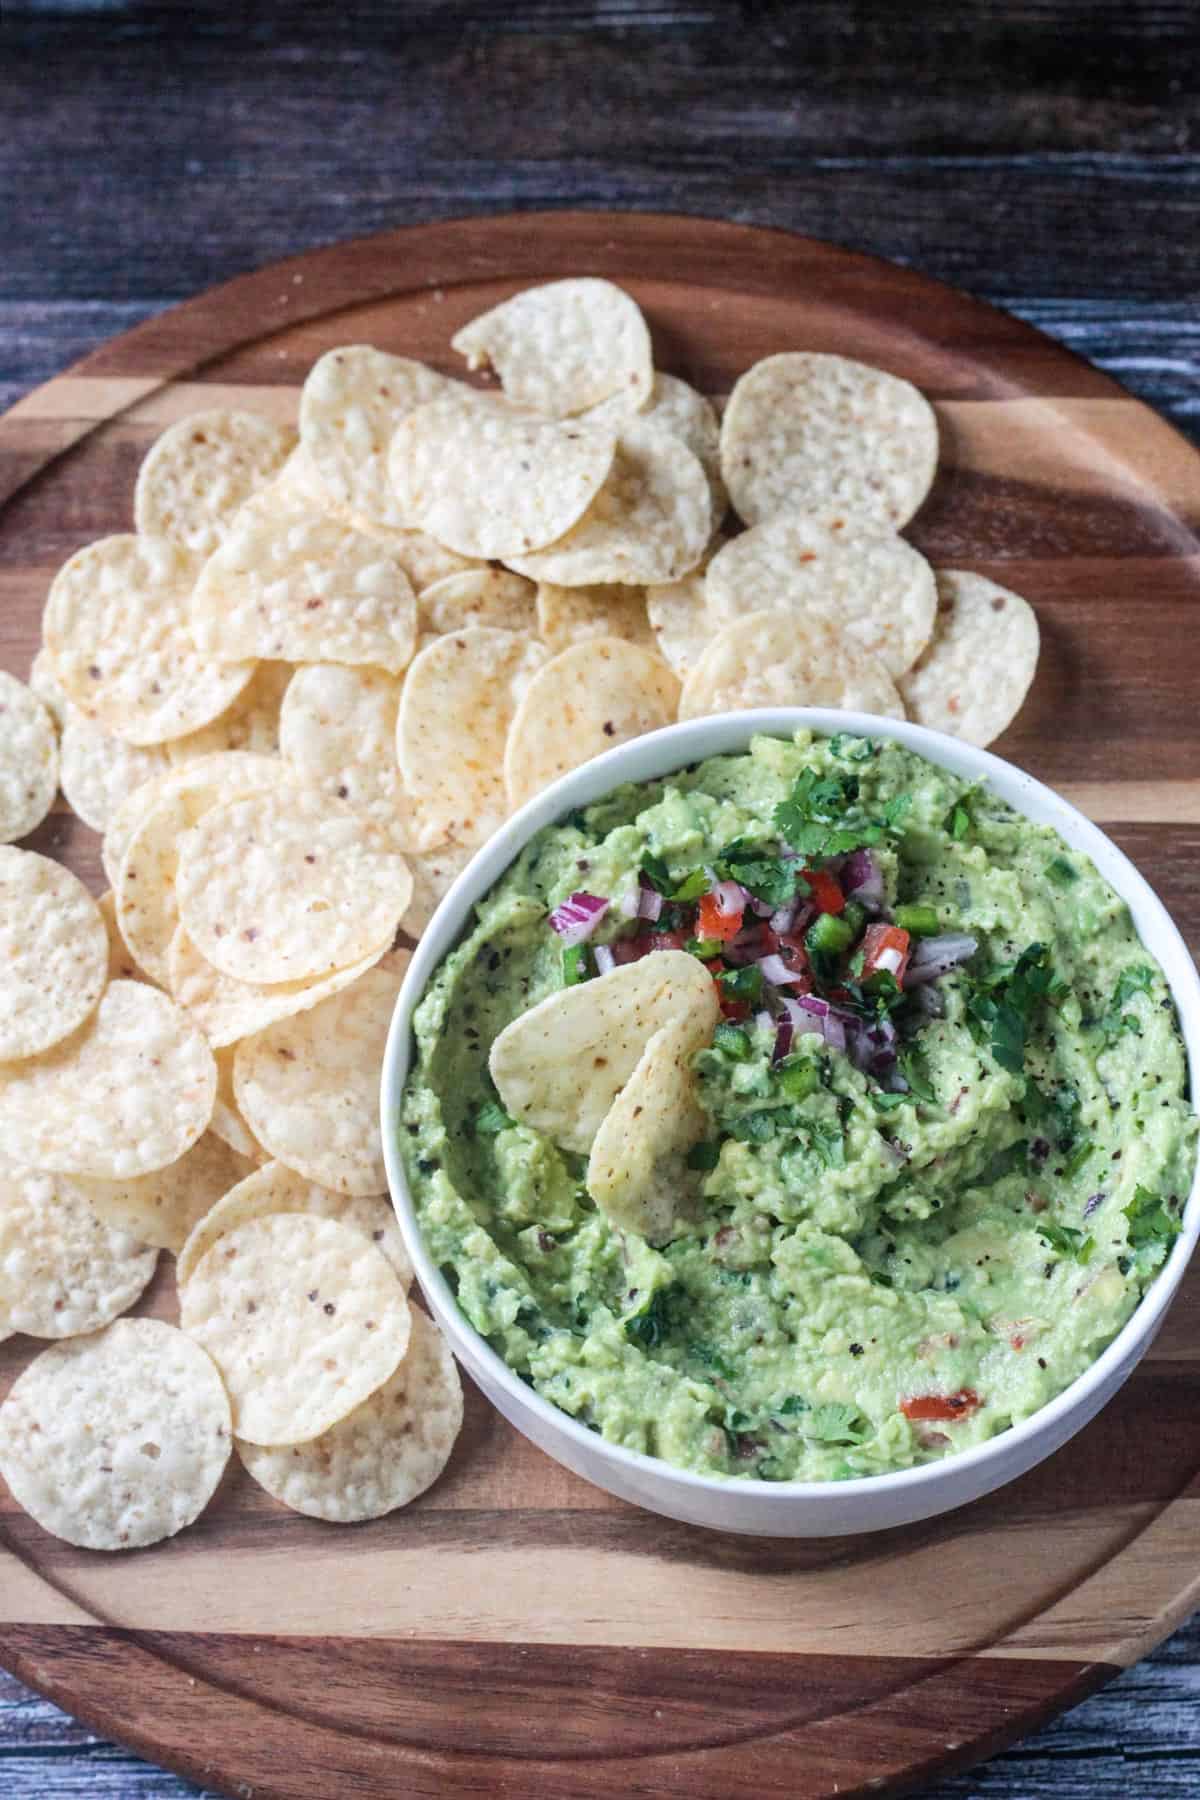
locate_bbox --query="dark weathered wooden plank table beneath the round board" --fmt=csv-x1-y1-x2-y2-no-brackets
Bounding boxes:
0,0,1200,1800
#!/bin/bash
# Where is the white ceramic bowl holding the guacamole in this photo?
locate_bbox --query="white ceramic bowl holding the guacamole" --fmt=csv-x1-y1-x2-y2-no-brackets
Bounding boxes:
381,707,1200,1537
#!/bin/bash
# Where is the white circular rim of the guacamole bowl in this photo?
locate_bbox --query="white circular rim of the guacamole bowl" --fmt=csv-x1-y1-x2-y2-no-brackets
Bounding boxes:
380,707,1200,1508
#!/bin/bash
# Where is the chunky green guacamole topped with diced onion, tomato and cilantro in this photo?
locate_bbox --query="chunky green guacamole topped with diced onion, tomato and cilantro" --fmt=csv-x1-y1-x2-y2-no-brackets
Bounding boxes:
399,731,1196,1481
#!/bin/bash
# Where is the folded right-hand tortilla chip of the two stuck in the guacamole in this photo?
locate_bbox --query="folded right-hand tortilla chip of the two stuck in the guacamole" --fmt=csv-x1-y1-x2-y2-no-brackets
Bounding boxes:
587,1013,712,1244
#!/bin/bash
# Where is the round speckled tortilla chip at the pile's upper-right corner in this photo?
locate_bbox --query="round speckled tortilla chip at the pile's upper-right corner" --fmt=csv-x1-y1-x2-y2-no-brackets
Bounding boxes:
721,351,937,531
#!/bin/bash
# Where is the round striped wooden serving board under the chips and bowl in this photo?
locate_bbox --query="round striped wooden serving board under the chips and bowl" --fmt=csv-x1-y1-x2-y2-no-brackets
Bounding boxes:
0,214,1200,1800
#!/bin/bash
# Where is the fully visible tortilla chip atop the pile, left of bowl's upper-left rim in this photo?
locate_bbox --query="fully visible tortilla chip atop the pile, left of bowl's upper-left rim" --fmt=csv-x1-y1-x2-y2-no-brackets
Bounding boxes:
174,788,412,983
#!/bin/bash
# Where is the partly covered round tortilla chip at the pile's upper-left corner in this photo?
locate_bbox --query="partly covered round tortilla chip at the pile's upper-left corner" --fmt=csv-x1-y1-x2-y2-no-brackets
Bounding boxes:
133,407,295,556
